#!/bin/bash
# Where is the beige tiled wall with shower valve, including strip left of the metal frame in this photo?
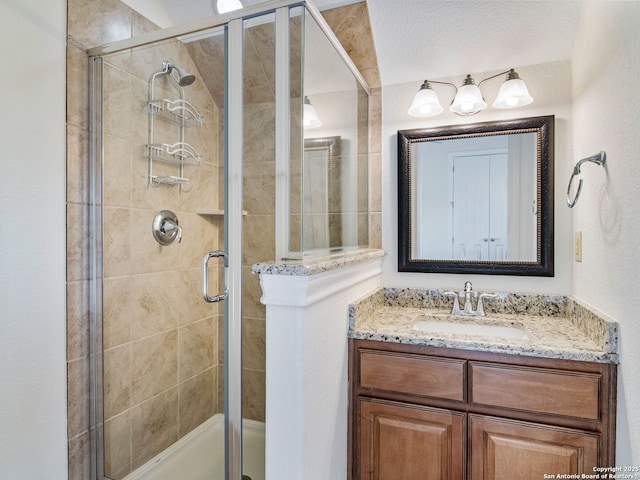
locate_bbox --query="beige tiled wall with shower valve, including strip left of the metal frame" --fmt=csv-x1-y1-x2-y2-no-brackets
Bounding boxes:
68,0,222,478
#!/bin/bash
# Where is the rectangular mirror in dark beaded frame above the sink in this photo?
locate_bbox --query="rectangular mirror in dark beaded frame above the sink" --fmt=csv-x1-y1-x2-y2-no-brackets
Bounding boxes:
398,116,554,277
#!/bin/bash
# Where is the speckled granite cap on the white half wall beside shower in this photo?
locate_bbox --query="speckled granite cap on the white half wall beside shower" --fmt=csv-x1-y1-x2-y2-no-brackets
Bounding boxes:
251,249,384,276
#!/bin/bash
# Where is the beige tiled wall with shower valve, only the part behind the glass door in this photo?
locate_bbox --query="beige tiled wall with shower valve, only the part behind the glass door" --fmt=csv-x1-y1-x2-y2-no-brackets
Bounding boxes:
103,45,220,478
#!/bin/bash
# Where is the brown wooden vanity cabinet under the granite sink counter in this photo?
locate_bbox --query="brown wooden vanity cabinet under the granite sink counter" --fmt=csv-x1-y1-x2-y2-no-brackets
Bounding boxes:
349,339,616,480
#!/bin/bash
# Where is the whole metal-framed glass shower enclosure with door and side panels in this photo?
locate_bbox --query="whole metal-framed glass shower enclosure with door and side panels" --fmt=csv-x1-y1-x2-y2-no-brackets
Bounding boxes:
89,1,369,480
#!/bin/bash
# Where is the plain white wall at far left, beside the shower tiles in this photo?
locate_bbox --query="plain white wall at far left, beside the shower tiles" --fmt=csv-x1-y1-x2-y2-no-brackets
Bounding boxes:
0,0,67,480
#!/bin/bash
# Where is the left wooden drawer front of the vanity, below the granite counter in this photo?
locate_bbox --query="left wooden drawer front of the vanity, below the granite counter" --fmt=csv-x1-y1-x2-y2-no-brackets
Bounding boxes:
358,350,466,401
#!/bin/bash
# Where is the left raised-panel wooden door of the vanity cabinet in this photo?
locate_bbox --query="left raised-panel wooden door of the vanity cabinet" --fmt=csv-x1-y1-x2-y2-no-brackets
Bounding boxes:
359,398,466,480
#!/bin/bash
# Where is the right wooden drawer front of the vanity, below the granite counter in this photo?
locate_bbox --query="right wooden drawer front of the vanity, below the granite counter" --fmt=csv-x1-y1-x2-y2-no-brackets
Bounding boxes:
469,362,601,420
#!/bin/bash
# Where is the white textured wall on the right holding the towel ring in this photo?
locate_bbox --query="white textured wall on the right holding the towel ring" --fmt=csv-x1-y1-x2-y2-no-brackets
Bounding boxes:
562,2,640,466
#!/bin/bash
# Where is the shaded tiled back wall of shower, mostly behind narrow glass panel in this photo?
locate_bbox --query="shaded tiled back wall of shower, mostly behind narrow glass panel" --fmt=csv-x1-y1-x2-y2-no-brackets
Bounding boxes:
186,22,275,421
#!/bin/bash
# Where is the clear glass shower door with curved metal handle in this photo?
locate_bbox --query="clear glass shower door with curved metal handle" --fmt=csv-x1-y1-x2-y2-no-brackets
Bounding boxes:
93,26,234,480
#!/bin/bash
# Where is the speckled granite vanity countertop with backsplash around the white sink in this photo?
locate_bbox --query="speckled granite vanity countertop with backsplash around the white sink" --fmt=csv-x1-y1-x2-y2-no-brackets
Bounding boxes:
349,288,618,363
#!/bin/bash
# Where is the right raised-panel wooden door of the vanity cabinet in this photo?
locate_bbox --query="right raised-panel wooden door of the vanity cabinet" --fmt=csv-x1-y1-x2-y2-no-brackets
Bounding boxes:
469,415,599,480
